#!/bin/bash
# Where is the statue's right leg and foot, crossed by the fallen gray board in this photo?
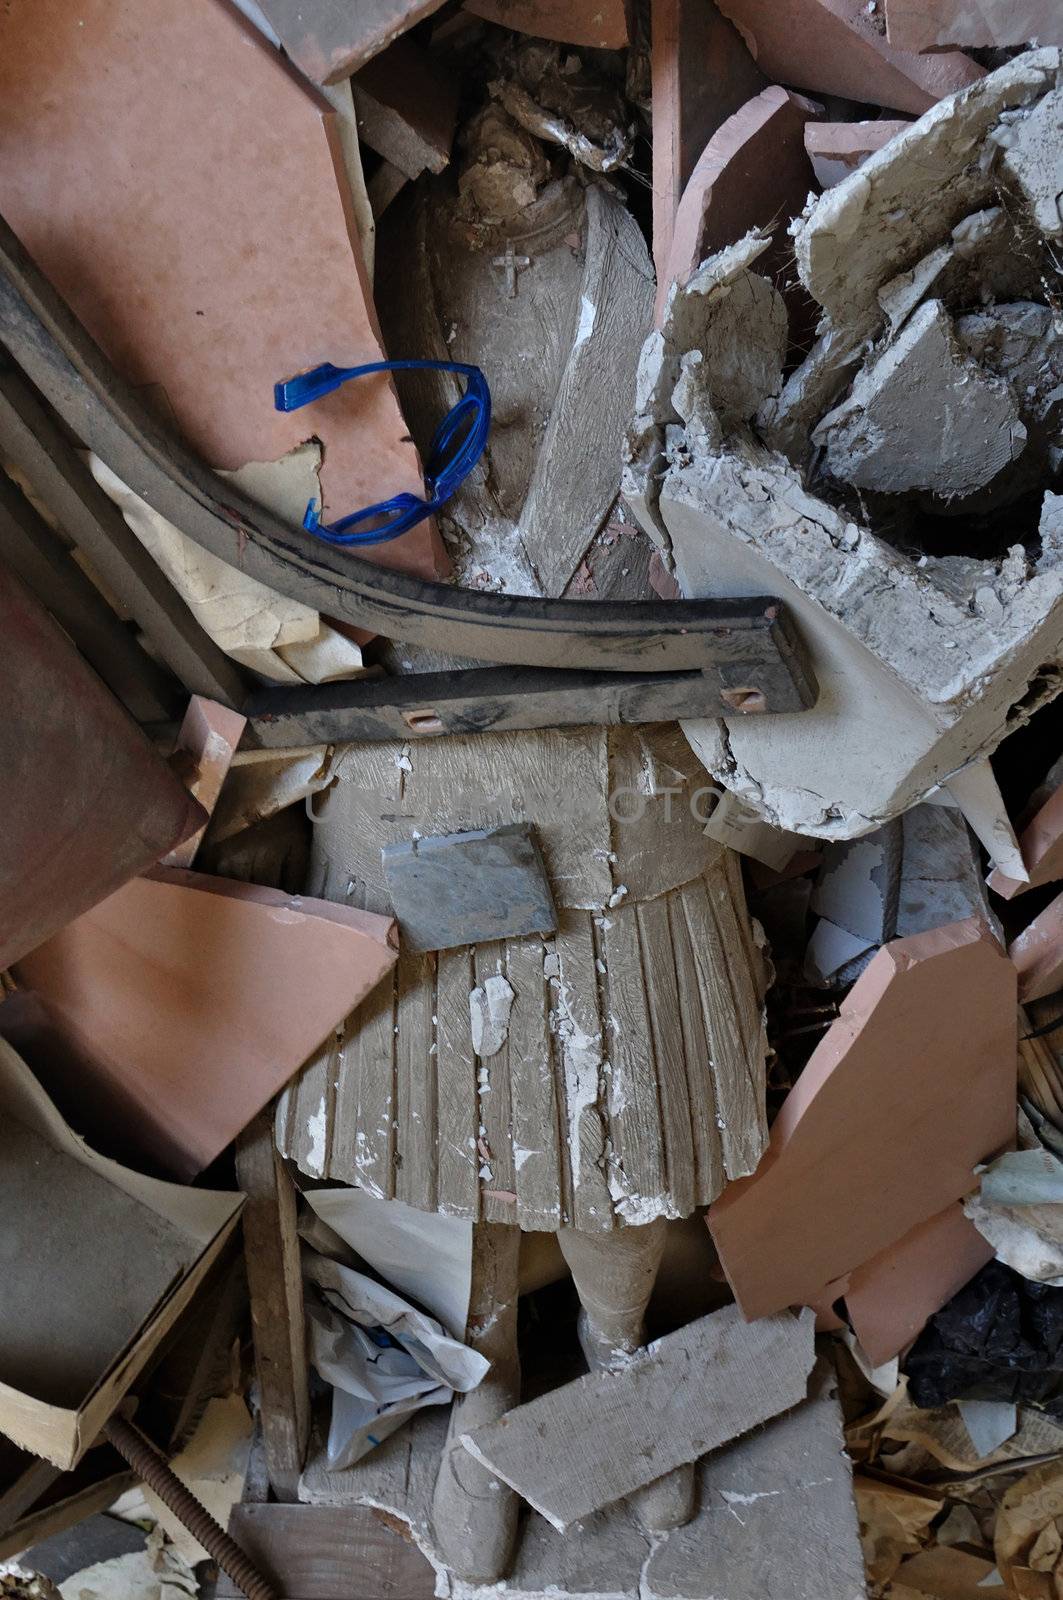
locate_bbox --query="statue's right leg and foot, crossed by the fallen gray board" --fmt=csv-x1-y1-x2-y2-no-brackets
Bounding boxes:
557,1219,695,1533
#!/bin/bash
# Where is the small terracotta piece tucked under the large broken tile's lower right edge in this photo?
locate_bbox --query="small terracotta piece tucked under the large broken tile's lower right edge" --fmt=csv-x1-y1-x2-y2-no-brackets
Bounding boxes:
844,1202,993,1366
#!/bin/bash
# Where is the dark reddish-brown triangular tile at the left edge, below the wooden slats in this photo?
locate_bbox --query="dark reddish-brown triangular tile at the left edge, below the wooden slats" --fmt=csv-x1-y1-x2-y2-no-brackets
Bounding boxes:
0,565,205,970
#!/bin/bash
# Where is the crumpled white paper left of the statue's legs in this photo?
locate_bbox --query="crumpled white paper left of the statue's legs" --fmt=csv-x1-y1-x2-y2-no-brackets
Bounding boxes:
303,1246,491,1470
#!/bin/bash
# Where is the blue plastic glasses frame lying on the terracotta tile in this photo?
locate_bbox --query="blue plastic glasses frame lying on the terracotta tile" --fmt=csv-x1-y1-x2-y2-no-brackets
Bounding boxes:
274,362,491,546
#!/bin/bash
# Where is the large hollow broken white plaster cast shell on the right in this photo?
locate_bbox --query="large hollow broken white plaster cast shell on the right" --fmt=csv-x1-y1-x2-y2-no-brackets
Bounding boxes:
624,50,1063,838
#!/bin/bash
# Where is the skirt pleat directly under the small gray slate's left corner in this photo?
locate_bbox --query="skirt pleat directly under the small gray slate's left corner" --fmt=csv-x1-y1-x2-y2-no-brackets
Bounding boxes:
395,946,439,1211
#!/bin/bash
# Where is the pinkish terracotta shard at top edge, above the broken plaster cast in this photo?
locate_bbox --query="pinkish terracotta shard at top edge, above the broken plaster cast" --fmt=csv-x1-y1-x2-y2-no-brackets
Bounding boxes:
720,0,985,117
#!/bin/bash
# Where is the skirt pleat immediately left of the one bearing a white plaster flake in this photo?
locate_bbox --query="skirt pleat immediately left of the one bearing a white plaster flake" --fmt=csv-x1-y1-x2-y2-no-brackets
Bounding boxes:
435,949,480,1222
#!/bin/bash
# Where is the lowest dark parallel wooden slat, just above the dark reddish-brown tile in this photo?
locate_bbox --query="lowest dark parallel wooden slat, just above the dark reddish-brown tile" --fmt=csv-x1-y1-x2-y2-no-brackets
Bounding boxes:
0,470,184,722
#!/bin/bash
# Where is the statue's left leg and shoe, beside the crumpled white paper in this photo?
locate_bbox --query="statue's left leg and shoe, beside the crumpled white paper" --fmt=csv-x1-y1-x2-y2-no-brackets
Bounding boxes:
432,1222,520,1584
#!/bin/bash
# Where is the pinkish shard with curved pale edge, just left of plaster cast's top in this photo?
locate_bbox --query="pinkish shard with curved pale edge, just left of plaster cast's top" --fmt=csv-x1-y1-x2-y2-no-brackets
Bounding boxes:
656,88,820,322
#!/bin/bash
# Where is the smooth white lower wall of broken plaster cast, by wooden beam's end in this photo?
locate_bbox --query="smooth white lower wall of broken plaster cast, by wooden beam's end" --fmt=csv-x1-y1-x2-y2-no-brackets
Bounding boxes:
661,438,1063,838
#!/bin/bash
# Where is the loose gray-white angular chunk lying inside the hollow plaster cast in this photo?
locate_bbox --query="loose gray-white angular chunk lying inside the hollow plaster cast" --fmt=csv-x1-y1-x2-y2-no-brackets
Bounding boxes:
812,301,1026,499
